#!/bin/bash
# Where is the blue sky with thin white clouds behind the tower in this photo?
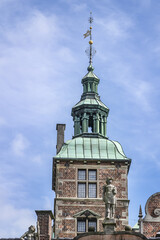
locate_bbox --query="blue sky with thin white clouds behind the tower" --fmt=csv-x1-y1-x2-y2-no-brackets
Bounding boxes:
0,0,160,238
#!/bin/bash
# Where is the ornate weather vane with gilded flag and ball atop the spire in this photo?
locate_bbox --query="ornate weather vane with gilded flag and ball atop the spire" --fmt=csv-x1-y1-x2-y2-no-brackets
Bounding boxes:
83,12,96,65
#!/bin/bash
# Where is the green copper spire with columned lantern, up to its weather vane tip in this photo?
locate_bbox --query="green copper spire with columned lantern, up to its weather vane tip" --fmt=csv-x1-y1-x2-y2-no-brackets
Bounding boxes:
72,15,109,138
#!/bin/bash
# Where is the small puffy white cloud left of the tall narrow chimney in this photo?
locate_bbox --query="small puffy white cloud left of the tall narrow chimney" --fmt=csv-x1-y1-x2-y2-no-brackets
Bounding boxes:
11,133,30,156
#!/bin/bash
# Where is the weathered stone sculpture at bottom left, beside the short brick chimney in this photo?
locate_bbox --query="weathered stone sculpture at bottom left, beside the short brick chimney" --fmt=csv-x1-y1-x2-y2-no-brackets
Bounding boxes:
20,222,40,240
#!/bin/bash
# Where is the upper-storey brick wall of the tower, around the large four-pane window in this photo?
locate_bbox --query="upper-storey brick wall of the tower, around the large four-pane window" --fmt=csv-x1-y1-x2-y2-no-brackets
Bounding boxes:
56,163,128,199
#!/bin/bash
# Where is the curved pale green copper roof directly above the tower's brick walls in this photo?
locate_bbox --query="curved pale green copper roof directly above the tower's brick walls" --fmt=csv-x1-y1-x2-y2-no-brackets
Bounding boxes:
55,137,129,160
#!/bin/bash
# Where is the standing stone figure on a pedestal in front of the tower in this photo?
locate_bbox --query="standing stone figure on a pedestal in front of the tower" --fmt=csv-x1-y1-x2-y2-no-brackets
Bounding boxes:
103,178,117,219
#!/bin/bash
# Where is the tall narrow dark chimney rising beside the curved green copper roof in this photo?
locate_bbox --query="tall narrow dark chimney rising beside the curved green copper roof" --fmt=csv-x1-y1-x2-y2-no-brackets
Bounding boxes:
56,124,66,153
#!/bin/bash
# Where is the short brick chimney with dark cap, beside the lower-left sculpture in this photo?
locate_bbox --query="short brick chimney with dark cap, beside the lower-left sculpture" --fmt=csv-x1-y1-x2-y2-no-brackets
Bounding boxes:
35,210,53,240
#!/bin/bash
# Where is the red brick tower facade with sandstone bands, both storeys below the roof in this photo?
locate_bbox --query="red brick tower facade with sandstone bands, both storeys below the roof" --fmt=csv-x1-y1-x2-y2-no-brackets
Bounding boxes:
54,160,129,238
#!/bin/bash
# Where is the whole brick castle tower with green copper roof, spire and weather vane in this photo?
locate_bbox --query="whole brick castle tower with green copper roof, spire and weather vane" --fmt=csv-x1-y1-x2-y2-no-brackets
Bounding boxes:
52,14,131,238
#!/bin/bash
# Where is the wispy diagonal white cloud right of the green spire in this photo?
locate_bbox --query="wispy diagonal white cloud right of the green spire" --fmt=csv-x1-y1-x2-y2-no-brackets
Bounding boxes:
104,59,154,112
